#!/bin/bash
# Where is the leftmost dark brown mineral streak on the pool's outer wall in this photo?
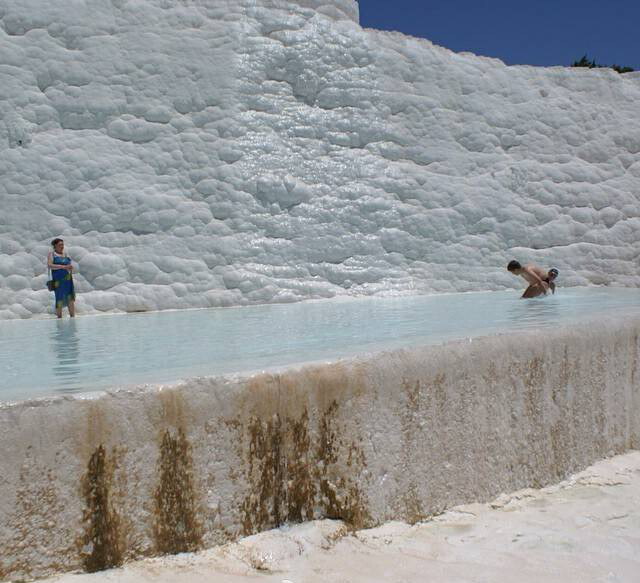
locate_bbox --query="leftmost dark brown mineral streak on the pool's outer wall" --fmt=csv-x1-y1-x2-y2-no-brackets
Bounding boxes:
78,445,123,573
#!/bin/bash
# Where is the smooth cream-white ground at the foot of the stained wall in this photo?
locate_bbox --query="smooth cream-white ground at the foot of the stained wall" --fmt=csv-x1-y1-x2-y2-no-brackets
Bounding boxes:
41,451,640,583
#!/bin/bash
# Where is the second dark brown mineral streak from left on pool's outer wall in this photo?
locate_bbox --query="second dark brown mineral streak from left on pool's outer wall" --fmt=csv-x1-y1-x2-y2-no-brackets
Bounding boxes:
153,429,202,554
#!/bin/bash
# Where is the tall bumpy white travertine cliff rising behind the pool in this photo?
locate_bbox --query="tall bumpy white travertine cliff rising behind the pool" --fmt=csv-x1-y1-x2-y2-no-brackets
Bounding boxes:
0,0,640,318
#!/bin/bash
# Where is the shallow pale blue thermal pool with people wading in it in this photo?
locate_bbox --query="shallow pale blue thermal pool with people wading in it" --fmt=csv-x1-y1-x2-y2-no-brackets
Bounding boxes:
0,287,640,401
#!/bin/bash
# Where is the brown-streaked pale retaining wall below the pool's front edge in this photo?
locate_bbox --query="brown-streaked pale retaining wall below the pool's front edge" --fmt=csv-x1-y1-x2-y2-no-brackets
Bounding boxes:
0,319,640,579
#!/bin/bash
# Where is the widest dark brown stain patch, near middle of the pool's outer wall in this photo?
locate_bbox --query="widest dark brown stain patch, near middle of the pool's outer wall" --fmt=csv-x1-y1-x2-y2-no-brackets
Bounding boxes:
240,401,369,535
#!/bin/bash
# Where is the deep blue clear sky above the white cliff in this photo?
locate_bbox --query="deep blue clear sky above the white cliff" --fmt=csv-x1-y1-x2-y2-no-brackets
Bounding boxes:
359,0,640,71
